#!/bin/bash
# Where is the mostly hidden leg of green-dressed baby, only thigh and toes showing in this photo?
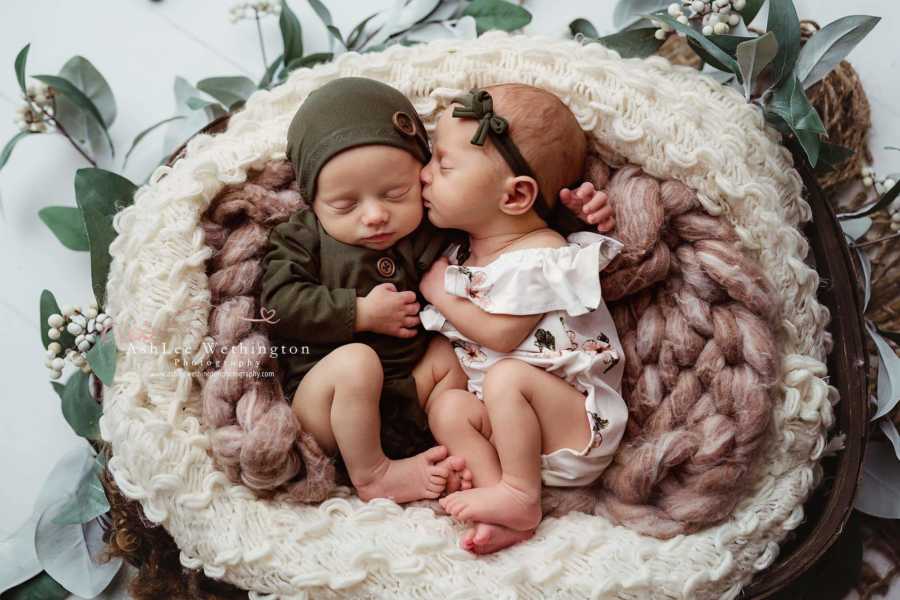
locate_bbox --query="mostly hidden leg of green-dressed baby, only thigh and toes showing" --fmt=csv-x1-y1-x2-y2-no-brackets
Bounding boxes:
412,335,472,493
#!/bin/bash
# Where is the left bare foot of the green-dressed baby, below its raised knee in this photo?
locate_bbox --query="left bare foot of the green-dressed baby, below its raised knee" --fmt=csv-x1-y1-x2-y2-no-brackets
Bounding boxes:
353,446,450,504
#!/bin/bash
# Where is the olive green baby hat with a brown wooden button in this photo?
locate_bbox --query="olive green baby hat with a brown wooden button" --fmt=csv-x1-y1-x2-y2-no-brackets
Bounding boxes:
287,77,431,204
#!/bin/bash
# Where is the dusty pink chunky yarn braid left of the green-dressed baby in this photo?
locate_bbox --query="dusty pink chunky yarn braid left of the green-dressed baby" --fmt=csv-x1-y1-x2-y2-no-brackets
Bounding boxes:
201,161,336,502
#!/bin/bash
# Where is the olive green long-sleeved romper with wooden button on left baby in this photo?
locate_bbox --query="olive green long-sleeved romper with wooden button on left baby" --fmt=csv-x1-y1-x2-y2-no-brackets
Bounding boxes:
260,208,458,458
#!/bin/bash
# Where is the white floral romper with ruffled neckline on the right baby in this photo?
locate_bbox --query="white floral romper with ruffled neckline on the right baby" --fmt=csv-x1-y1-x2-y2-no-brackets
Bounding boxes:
419,231,628,487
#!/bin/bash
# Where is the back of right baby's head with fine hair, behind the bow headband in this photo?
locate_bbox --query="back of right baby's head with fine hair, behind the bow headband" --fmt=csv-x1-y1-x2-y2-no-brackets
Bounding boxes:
485,83,587,208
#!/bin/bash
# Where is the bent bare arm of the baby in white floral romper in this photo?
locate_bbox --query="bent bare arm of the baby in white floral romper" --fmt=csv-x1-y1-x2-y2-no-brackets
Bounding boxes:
419,257,544,352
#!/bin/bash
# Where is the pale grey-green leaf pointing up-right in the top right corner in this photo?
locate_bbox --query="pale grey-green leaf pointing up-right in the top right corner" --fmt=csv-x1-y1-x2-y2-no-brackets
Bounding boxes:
794,15,881,89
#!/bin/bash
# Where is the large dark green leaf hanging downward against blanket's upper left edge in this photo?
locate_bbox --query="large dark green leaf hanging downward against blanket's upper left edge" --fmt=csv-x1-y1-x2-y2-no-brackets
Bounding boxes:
75,169,137,308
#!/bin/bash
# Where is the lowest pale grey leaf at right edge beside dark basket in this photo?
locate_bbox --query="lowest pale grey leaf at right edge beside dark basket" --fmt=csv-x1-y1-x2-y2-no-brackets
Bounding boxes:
854,442,900,519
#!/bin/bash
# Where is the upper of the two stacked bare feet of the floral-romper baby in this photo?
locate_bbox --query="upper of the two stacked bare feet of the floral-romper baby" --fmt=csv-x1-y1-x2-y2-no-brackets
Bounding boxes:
438,479,541,531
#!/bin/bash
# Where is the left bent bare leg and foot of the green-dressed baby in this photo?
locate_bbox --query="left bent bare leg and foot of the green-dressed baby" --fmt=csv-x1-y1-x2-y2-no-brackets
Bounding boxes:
292,344,449,502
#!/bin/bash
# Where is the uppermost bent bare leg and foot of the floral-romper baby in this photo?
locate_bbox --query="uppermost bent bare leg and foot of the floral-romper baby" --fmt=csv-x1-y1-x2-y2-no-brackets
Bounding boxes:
440,359,590,530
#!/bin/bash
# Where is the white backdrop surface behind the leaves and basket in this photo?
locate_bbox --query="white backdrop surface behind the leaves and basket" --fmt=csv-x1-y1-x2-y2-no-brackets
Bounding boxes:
0,0,900,596
